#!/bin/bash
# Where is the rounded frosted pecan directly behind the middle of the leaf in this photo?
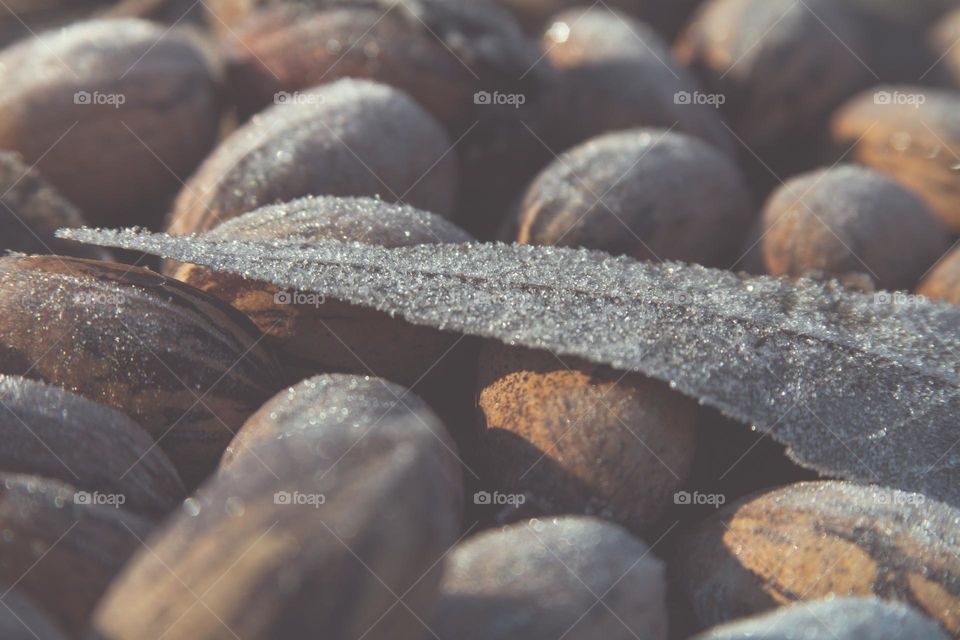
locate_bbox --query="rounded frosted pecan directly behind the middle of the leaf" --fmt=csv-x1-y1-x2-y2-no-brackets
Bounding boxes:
516,129,753,267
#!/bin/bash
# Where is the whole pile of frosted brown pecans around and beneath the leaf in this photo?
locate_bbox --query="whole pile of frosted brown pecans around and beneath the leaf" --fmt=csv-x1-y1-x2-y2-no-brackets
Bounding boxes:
0,0,960,640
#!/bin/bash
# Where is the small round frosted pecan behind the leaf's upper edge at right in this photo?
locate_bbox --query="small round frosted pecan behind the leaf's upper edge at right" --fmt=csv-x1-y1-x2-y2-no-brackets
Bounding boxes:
762,165,950,291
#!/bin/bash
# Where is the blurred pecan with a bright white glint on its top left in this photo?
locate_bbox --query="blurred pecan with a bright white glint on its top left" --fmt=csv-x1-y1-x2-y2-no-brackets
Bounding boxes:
541,5,736,155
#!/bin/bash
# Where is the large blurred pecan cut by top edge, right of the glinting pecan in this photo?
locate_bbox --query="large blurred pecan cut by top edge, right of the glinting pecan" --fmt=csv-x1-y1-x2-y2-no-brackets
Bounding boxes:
674,0,874,153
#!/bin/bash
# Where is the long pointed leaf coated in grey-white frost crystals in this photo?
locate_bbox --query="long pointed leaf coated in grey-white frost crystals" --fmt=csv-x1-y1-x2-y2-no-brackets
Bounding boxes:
60,229,960,505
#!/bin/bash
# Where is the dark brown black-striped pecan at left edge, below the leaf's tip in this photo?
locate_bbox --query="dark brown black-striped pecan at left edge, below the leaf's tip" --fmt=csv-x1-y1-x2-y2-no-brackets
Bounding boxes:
0,256,282,488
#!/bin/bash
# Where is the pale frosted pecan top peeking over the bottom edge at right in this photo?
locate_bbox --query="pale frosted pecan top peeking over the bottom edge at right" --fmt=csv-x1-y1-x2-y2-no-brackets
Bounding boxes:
694,598,948,640
